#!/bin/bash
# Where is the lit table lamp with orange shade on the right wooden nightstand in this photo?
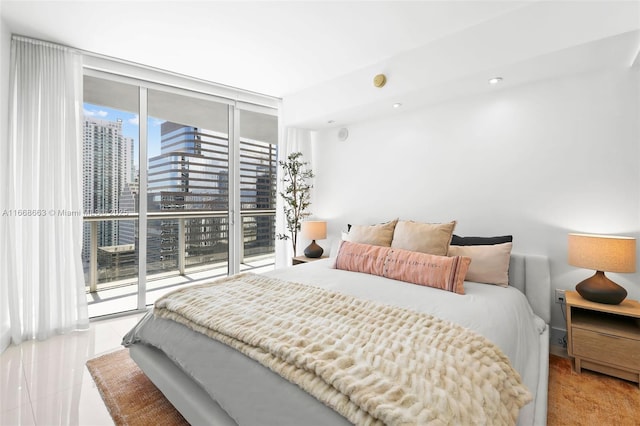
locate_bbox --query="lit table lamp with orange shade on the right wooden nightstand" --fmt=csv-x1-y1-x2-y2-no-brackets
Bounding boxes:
568,234,636,305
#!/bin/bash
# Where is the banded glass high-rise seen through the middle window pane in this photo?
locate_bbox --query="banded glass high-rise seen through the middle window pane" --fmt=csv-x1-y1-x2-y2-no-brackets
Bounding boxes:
147,121,229,269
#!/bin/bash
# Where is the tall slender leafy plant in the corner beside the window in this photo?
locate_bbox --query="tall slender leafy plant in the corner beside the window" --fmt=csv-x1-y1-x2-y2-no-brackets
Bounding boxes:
278,152,314,256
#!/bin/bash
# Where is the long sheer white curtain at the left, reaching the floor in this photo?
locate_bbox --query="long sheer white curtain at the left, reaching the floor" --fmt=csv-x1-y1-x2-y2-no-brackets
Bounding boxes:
0,36,89,344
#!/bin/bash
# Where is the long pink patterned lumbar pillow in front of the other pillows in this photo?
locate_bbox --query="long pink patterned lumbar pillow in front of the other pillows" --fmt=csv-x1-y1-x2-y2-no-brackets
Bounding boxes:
336,241,471,294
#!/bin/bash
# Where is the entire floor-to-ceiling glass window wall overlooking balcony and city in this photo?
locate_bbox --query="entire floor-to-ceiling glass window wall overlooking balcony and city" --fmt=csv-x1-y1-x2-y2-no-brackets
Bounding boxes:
82,72,278,316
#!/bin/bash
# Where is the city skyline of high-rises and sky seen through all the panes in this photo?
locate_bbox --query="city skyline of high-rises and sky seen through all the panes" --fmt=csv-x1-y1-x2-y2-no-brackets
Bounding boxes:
83,103,277,282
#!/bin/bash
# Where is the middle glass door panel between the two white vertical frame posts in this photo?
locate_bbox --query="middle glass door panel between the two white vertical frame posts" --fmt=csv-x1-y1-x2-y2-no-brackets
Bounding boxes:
146,89,229,303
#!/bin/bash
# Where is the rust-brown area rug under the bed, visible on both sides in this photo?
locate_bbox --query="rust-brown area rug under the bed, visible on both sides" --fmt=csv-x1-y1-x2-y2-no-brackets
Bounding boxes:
87,349,640,426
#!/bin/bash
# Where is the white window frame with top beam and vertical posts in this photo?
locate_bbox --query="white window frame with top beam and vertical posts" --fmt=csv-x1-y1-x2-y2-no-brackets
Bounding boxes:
83,66,281,310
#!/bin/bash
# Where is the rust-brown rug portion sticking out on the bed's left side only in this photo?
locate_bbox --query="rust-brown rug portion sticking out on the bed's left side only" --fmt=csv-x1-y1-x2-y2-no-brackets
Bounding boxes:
87,349,189,426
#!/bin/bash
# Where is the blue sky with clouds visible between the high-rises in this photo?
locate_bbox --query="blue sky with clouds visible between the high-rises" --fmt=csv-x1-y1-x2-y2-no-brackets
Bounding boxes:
84,102,164,167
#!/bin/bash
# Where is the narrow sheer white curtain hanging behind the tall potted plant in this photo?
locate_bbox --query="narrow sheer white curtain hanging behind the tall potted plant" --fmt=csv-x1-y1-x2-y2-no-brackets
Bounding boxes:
276,127,313,268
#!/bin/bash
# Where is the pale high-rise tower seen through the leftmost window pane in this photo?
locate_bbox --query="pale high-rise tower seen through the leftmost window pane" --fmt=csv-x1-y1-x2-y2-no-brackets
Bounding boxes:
83,117,134,260
